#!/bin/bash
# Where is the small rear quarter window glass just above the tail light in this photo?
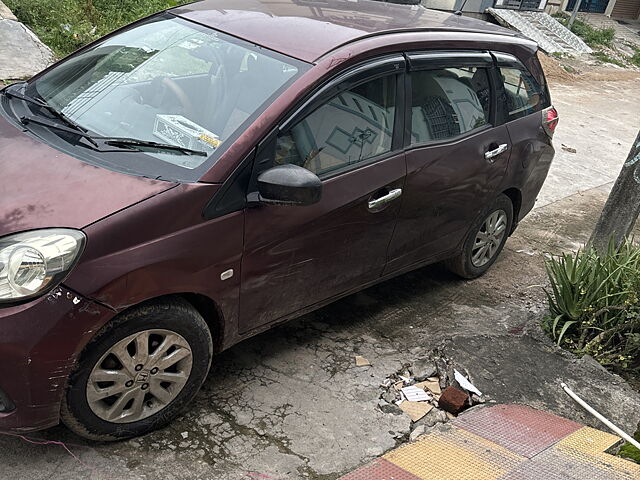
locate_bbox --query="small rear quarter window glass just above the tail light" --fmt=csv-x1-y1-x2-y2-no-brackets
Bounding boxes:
500,67,546,120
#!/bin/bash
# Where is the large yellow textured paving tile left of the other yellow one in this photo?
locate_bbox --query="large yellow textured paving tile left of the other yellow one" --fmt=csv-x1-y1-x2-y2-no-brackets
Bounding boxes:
384,427,526,480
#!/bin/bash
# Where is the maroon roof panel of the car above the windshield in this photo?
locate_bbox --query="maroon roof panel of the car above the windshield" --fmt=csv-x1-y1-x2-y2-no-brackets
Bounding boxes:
171,0,517,63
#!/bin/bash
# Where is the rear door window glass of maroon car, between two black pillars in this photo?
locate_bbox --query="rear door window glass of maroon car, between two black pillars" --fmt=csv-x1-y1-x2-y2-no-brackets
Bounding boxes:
411,67,491,144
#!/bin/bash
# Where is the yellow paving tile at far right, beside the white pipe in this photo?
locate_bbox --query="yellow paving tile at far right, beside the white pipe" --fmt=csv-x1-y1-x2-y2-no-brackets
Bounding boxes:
554,427,640,480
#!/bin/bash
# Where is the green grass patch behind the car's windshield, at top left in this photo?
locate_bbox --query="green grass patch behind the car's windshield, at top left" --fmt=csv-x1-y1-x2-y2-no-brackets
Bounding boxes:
3,0,187,57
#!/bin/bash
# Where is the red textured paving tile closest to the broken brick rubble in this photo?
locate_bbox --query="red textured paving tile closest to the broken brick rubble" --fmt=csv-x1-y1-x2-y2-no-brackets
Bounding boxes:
453,405,581,458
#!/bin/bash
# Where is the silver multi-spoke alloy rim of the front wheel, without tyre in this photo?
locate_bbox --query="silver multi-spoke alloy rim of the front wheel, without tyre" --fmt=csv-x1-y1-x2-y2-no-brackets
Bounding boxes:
86,330,193,423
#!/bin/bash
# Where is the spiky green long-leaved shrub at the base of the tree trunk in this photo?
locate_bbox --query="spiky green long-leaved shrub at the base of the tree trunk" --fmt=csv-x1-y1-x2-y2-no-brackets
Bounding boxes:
543,242,640,372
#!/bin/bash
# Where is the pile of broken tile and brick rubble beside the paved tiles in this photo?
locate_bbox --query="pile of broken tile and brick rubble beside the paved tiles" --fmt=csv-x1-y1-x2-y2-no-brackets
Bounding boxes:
378,357,486,439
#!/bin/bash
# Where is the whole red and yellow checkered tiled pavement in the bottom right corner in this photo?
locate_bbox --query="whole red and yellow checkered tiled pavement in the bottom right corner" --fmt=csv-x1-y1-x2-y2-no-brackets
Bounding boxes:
340,405,640,480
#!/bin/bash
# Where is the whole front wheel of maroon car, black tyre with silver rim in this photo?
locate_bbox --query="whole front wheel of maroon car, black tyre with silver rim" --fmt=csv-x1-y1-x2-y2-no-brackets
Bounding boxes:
61,299,213,441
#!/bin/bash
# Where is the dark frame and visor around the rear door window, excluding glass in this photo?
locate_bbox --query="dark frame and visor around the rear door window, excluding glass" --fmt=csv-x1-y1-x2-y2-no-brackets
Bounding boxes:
403,50,503,150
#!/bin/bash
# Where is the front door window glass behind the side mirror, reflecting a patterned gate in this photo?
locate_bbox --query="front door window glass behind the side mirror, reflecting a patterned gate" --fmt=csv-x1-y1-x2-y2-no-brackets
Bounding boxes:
274,75,396,175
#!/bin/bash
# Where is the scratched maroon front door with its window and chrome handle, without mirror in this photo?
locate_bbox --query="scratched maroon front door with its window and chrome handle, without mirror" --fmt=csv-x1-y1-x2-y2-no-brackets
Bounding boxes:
240,58,406,332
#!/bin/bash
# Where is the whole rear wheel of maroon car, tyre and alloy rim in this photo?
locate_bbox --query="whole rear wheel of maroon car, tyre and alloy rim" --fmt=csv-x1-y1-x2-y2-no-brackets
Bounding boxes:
444,194,513,279
